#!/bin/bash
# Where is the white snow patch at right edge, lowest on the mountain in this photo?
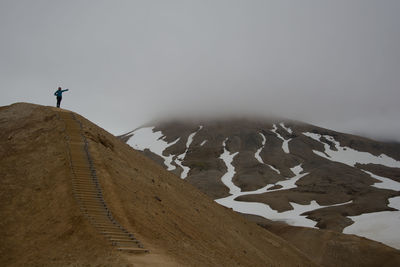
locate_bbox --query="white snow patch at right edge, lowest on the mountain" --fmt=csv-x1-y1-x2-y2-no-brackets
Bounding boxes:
343,197,400,249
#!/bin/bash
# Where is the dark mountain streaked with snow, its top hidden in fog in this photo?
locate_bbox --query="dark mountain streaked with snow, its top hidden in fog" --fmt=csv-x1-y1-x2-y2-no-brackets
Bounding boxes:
121,119,400,248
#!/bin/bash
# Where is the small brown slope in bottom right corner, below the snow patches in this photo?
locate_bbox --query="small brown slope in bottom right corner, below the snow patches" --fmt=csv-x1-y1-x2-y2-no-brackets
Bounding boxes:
245,215,400,267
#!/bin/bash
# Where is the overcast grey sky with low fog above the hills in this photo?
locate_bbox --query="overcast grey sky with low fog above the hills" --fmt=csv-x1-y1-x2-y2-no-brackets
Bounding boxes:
0,0,400,141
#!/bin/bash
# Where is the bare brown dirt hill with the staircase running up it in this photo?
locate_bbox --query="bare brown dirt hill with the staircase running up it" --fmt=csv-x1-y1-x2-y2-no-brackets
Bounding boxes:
0,103,314,266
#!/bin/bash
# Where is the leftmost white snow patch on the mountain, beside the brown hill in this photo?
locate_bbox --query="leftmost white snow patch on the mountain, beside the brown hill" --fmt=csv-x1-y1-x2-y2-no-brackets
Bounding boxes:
127,127,179,171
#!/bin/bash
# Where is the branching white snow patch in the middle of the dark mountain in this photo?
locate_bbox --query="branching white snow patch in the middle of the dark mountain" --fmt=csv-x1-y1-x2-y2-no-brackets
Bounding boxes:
215,149,351,227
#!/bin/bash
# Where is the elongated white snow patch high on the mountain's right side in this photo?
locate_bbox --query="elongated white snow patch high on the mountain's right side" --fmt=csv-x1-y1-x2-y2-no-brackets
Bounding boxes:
303,132,400,168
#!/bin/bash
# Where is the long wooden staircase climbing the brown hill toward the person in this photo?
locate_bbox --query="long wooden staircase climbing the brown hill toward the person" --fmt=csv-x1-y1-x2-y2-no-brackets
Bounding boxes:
58,110,149,253
